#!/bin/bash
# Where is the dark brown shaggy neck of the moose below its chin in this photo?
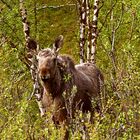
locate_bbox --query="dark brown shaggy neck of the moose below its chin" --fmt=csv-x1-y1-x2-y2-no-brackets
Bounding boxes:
44,68,63,99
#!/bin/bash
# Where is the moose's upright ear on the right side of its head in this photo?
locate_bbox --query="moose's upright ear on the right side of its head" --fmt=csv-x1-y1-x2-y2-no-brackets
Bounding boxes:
53,35,63,56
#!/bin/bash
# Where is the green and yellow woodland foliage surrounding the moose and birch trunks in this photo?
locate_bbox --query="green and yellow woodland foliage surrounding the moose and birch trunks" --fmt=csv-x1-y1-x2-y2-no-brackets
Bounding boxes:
0,0,140,140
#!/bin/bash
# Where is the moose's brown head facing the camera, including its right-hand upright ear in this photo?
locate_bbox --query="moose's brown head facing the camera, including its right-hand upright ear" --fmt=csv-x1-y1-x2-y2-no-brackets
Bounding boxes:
37,35,63,82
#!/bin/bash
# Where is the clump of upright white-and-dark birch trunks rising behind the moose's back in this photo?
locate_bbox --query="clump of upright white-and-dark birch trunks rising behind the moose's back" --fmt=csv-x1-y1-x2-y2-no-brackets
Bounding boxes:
78,0,99,63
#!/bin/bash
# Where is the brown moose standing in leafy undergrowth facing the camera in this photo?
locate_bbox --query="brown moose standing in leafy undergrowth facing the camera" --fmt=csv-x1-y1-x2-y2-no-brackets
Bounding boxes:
37,35,103,139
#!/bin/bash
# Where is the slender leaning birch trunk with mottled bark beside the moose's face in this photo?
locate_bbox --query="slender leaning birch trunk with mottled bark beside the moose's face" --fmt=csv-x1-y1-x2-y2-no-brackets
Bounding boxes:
19,0,43,113
